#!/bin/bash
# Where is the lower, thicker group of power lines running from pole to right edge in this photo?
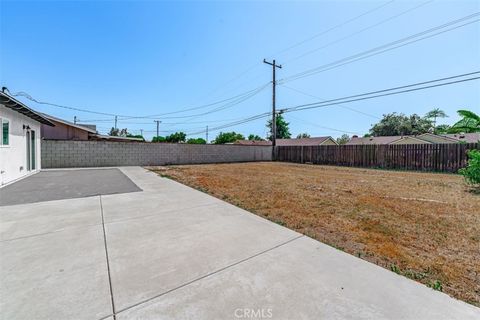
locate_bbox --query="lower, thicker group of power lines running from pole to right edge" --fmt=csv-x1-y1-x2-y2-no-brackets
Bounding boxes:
281,71,480,112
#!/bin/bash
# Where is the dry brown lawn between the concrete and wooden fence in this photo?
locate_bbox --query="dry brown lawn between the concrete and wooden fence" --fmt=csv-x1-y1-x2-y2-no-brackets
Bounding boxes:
151,162,480,306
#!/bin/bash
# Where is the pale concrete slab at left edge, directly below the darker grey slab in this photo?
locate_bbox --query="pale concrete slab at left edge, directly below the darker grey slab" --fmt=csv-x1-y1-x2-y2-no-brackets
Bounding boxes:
0,197,102,241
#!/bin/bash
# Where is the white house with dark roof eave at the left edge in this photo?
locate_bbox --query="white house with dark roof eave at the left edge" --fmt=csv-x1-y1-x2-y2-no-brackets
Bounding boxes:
0,92,54,186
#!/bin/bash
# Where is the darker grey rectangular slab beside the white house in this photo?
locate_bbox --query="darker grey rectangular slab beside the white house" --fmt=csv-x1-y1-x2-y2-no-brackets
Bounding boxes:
0,169,141,206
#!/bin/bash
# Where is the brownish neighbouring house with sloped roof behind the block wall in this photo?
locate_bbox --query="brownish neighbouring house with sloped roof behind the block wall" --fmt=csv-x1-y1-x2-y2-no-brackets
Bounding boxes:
41,114,143,142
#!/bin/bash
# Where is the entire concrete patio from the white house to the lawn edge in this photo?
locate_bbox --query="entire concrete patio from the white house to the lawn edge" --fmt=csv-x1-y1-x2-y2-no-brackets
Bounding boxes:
0,167,480,320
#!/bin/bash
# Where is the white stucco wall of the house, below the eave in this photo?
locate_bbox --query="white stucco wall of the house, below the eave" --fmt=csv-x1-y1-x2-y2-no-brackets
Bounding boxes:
0,104,41,186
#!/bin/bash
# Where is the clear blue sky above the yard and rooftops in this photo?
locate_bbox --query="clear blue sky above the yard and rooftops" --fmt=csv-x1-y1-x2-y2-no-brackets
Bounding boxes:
0,0,480,140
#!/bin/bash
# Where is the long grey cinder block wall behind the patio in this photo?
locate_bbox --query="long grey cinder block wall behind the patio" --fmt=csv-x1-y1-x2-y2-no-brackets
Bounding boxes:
41,140,272,168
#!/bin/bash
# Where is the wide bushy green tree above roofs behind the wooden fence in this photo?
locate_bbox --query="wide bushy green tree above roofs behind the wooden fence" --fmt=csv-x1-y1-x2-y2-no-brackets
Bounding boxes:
370,112,432,137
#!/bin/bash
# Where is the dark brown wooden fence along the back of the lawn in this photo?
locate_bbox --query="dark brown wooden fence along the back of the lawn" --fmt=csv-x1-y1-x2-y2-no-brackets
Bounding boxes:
275,143,480,172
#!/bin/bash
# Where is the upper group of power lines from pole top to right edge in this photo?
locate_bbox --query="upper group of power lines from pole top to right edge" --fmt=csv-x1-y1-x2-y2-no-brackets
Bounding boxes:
279,12,480,84
